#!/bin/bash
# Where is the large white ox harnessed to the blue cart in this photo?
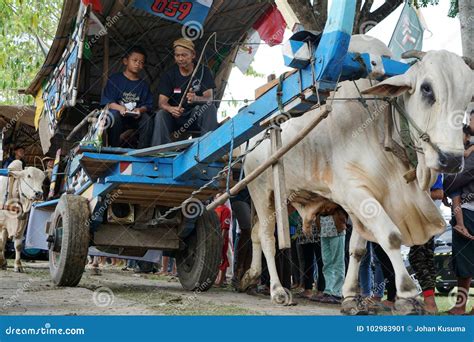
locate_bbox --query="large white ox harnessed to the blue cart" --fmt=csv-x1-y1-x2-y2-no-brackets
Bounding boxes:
241,36,474,313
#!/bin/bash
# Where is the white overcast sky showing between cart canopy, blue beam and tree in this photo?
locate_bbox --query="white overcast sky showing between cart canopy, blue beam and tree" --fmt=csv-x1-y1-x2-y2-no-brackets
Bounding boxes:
219,0,462,120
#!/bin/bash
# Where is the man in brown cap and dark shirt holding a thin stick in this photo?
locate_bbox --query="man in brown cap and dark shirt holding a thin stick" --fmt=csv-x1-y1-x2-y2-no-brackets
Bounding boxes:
151,38,218,146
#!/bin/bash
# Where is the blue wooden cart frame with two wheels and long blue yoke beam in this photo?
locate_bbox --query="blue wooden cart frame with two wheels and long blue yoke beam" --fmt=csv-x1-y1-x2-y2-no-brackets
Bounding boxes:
14,0,408,290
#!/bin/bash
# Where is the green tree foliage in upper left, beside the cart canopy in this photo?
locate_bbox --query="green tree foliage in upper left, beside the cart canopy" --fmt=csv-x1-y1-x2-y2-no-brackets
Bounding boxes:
0,0,63,104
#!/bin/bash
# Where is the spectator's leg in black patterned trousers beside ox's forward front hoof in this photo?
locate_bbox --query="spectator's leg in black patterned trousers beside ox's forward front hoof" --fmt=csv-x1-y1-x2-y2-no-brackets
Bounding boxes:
408,238,438,313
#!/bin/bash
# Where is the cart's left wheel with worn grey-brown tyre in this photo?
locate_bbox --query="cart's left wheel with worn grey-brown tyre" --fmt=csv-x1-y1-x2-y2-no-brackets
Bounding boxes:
49,194,90,286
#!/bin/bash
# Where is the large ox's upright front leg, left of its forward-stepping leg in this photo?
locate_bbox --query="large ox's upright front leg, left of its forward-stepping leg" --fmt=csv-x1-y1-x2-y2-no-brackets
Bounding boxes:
341,222,369,315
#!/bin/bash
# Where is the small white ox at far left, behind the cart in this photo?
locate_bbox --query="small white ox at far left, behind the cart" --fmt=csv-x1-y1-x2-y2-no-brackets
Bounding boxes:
0,160,45,272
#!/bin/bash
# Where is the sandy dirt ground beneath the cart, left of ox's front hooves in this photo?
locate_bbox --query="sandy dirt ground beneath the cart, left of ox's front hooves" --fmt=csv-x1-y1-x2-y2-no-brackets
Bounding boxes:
0,260,340,315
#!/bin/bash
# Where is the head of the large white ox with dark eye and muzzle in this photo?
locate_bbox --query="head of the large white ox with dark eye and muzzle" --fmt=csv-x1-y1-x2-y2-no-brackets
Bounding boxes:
363,51,474,190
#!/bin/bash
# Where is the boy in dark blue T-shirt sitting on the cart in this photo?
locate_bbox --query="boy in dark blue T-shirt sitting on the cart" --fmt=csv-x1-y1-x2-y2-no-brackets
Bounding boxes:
101,46,153,149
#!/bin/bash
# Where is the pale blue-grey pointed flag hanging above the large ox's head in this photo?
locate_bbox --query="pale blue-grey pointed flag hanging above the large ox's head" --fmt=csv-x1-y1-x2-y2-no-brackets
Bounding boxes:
388,3,424,59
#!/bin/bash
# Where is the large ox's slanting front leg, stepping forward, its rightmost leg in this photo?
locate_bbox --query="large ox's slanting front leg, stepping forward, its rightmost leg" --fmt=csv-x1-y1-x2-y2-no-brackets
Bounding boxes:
349,191,422,314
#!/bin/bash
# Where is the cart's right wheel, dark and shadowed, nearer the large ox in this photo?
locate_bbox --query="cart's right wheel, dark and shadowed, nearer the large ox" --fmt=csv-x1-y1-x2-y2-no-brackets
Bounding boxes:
176,211,222,291
